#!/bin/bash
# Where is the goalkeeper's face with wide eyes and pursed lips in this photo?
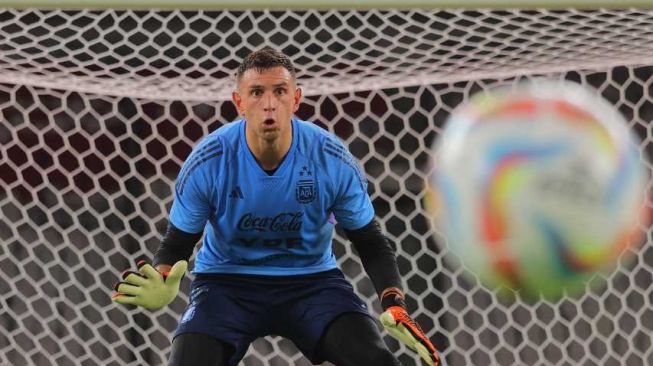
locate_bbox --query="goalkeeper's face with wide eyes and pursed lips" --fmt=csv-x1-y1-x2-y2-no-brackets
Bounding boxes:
232,66,302,141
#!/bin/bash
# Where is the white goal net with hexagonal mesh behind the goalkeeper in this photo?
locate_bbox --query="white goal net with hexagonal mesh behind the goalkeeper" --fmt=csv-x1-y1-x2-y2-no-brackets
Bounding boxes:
0,9,653,366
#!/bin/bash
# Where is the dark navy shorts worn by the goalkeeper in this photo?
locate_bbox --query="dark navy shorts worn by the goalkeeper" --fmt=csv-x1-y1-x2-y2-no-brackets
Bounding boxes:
175,269,370,366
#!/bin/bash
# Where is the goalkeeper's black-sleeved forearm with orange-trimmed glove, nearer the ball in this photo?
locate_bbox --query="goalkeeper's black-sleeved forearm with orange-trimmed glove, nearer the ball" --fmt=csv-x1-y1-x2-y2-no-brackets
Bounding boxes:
345,219,440,366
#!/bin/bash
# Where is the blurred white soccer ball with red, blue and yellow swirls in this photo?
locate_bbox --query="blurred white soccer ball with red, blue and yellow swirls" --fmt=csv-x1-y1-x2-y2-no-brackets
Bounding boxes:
427,80,648,298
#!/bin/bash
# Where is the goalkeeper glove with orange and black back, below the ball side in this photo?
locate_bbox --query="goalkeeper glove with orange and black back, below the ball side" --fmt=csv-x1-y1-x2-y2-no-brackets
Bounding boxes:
380,289,440,366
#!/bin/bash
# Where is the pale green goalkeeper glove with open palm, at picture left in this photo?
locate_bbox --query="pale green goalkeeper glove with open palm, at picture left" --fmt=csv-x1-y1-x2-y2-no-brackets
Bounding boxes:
111,260,188,310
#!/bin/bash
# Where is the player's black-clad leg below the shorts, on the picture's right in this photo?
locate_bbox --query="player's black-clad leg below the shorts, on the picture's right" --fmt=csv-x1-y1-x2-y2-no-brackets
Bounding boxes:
317,313,401,366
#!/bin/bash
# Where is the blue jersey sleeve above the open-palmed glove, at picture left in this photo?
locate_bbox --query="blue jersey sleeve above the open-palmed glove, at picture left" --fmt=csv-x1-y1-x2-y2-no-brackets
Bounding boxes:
170,137,222,233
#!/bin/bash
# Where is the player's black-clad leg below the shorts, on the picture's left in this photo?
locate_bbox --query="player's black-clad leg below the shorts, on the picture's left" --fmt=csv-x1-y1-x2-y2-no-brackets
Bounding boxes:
168,333,234,366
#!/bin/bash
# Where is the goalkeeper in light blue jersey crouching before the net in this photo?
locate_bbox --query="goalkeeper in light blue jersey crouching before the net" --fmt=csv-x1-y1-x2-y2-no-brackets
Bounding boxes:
113,48,440,366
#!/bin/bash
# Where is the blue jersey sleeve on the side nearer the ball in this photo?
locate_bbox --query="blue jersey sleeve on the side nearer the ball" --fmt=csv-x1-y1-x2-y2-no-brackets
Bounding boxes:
324,139,374,230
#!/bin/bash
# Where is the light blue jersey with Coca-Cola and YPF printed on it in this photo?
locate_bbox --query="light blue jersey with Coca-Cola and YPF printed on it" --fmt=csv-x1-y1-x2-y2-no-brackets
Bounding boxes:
170,118,374,275
